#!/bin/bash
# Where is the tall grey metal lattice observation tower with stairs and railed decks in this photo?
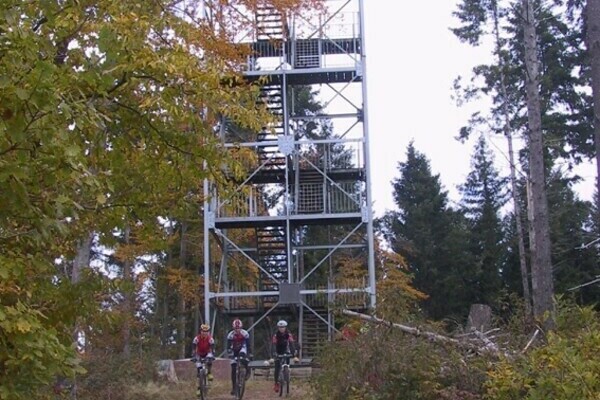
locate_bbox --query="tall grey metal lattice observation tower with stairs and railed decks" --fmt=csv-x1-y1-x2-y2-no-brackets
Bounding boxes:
204,0,375,356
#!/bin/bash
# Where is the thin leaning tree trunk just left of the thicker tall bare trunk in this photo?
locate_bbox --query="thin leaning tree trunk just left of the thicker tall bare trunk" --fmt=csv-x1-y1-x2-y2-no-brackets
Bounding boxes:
493,2,532,319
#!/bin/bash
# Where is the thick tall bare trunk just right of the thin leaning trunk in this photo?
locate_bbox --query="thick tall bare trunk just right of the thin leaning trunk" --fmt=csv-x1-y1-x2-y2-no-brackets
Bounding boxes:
522,0,554,327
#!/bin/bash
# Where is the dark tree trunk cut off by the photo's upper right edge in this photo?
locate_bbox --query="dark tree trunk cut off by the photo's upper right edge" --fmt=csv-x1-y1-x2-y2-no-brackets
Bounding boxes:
585,0,600,205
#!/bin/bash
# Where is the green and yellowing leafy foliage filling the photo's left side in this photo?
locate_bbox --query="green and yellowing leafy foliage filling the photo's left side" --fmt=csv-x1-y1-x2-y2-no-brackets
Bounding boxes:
0,0,314,399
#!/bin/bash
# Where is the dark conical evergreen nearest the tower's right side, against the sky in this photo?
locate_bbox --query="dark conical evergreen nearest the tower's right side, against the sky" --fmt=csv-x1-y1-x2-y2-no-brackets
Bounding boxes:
380,143,470,318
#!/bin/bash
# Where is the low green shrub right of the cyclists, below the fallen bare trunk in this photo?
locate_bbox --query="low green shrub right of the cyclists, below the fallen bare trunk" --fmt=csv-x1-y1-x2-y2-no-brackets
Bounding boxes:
313,326,485,400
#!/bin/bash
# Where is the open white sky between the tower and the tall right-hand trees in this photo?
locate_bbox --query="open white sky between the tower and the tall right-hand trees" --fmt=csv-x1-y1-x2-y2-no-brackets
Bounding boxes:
365,0,595,216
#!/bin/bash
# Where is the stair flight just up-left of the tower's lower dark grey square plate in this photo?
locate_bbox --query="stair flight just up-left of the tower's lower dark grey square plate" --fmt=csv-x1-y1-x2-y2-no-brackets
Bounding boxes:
256,226,288,308
